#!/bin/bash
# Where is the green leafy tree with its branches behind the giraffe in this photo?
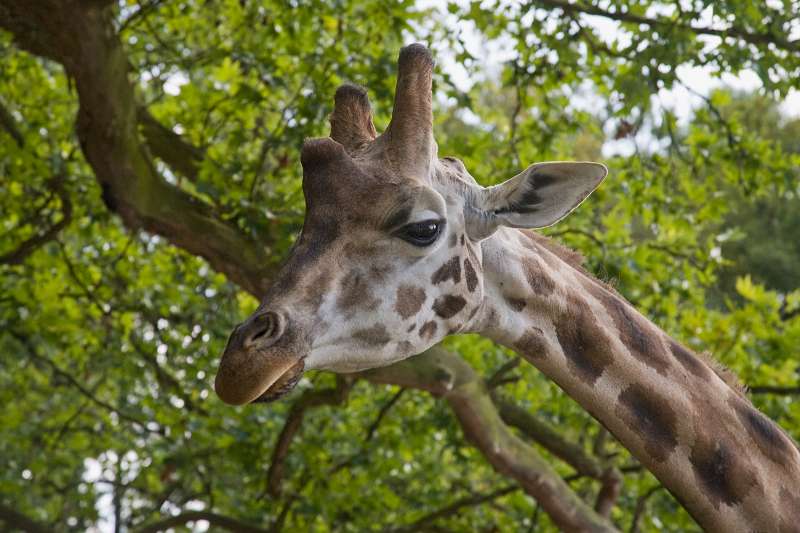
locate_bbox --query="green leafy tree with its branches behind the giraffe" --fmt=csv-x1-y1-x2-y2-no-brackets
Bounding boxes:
0,0,800,531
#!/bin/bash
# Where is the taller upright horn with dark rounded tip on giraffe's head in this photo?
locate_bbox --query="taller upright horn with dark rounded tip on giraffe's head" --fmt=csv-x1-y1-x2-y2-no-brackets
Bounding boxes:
383,43,436,177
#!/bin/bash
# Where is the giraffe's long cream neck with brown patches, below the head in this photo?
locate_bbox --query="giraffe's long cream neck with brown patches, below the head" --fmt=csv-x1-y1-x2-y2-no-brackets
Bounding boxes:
477,230,800,531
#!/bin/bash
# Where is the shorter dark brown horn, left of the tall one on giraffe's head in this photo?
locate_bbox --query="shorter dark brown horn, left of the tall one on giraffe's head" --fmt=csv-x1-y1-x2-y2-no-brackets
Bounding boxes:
330,83,377,152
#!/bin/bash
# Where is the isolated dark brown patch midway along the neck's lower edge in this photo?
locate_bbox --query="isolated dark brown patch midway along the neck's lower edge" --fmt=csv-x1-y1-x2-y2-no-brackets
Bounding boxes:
616,384,678,462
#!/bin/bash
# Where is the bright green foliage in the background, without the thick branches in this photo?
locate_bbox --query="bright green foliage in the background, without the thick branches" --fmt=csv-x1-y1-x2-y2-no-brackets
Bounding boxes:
0,0,800,531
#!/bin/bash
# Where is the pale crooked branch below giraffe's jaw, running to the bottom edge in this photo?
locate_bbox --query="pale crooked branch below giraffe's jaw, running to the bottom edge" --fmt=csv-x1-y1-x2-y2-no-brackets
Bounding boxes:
359,347,615,531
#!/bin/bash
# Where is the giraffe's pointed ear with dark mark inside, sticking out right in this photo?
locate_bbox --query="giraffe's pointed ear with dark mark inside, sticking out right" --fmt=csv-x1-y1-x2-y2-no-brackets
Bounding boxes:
467,162,608,240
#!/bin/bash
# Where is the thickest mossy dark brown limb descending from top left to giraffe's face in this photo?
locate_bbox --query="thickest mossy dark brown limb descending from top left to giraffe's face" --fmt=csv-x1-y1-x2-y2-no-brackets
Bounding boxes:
0,0,274,295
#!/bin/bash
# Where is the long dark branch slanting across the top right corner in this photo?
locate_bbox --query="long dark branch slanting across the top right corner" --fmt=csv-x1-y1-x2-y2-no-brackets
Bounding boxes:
531,0,800,51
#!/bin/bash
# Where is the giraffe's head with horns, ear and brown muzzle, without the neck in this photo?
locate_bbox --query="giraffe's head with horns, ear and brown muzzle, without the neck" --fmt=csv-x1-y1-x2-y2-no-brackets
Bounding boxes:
215,44,606,404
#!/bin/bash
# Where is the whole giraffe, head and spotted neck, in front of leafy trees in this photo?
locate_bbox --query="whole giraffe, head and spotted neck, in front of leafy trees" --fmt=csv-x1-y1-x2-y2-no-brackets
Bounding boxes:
215,44,800,532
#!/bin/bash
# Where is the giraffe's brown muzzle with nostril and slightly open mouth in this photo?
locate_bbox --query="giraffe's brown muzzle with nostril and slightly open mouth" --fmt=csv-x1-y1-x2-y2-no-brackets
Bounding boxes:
214,311,309,405
